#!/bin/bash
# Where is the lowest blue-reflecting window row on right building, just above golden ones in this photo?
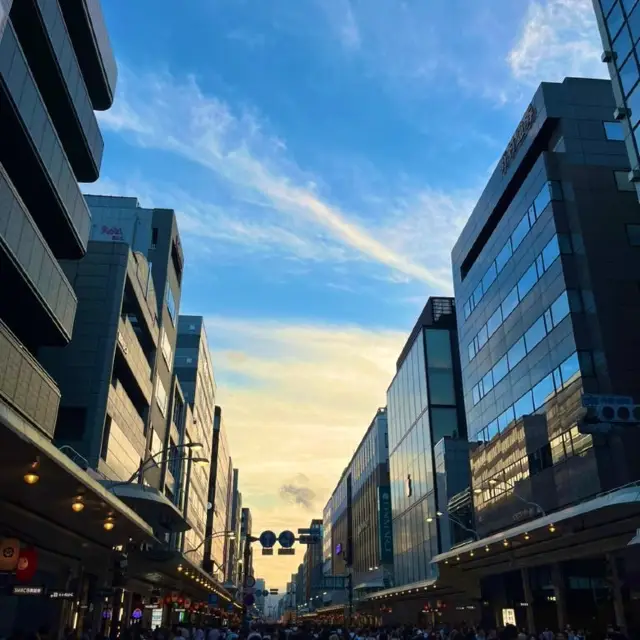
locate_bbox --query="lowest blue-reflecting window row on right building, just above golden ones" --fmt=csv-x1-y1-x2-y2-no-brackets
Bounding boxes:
474,351,593,442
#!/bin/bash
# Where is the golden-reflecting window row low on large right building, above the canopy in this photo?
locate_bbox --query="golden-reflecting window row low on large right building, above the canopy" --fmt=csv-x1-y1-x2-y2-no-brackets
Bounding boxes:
476,426,593,502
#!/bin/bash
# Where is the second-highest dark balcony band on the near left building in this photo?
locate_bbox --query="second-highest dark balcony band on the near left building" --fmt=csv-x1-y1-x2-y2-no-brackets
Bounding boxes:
11,0,104,182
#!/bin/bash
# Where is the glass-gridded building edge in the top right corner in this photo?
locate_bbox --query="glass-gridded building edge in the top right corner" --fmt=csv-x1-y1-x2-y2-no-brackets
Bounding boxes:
593,0,640,198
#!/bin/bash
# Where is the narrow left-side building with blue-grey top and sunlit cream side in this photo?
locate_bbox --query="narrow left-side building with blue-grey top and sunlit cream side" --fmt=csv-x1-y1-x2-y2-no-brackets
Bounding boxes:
172,315,216,564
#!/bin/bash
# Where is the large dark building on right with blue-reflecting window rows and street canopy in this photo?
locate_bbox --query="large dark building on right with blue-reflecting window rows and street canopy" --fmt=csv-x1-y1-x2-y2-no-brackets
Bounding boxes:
436,77,640,633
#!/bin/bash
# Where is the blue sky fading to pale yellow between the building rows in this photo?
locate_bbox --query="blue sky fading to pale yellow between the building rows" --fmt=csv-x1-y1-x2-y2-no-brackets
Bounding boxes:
89,0,606,589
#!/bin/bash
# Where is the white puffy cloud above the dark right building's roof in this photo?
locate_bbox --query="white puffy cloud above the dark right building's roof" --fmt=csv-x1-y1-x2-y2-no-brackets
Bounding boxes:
507,0,609,86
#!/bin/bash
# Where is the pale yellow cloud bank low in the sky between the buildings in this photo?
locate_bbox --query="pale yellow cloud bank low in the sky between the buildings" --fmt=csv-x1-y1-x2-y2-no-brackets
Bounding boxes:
195,310,406,582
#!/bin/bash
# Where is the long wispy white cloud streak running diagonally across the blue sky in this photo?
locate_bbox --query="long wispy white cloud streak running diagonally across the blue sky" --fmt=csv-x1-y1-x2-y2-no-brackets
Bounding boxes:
99,67,460,288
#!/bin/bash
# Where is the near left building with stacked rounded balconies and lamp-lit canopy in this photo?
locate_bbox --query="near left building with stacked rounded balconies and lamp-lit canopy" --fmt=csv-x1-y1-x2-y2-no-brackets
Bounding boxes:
0,0,159,637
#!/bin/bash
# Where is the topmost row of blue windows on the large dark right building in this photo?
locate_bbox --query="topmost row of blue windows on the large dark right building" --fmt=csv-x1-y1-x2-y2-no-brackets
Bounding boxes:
464,182,562,320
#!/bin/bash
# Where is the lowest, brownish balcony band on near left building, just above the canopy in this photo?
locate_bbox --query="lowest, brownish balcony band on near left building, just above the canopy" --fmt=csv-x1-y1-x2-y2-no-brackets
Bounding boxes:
0,320,60,438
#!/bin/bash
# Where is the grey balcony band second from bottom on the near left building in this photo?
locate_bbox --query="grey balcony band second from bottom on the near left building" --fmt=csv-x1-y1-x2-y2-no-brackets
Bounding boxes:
0,165,78,346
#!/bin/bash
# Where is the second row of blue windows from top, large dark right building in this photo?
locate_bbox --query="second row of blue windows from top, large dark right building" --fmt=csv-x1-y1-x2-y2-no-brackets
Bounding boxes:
467,236,571,362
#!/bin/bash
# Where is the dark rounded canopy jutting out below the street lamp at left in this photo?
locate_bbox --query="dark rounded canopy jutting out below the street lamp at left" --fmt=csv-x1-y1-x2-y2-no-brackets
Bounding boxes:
102,480,191,533
